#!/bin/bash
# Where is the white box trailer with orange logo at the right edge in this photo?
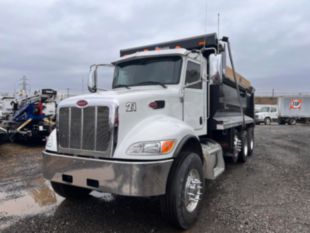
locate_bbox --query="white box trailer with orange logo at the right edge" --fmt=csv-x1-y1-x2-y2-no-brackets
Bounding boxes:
278,96,310,125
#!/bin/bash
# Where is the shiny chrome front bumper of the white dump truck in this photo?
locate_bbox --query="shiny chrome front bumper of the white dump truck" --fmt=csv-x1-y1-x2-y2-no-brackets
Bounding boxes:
43,151,173,197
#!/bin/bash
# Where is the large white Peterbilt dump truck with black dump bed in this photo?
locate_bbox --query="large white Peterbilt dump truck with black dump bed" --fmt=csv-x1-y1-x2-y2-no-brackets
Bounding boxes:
43,34,255,229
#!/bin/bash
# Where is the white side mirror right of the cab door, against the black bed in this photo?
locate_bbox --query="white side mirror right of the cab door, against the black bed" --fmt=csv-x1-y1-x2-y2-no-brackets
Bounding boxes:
209,54,223,85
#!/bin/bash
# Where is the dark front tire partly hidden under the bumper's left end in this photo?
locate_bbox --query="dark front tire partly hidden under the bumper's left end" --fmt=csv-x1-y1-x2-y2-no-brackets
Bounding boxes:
51,181,91,199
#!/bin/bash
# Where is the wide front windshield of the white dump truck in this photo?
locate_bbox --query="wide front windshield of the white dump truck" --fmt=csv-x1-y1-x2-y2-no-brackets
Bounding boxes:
113,56,182,88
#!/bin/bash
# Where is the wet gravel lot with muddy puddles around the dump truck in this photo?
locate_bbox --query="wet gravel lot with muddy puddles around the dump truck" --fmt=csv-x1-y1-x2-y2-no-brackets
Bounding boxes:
0,125,310,233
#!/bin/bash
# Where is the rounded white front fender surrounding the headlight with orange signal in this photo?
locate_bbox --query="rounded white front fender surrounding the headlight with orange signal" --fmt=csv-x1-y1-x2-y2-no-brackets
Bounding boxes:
113,115,196,160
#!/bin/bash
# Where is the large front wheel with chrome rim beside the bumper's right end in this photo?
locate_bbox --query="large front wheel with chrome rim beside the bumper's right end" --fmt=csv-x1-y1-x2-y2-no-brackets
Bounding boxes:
161,152,204,229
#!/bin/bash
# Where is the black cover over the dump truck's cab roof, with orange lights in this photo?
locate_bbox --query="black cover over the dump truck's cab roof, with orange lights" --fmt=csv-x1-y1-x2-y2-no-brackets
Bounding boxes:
120,33,218,57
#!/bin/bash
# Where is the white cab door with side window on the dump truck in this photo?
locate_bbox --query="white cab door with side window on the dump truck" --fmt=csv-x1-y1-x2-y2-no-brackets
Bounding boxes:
184,61,206,135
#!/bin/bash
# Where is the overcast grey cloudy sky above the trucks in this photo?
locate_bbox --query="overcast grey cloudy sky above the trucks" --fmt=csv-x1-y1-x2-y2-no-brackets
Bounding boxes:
0,0,310,95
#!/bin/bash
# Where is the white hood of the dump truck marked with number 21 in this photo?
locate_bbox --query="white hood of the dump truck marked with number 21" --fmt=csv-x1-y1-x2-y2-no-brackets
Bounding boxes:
59,86,182,147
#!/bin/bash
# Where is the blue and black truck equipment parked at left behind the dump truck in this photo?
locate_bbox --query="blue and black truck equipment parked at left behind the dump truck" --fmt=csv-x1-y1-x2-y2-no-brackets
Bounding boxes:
2,89,57,142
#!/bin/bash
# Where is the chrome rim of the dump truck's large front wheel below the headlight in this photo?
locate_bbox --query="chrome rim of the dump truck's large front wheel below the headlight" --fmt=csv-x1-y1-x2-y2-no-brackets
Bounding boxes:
184,169,202,212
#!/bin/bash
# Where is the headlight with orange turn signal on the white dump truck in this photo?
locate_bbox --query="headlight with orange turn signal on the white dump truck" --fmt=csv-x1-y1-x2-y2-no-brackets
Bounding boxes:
127,140,175,155
